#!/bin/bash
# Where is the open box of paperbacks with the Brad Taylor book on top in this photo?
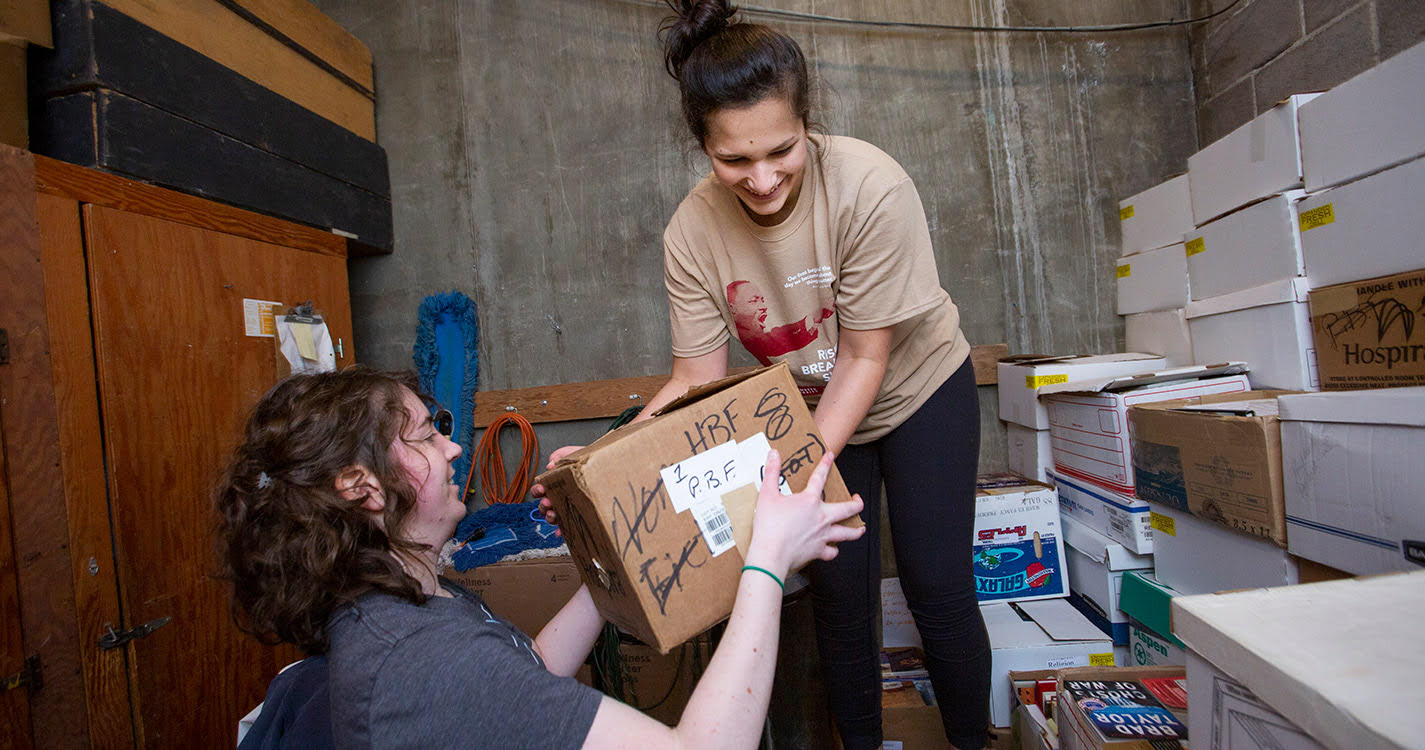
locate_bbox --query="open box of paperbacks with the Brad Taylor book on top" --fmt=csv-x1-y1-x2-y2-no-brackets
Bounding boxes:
1056,667,1190,750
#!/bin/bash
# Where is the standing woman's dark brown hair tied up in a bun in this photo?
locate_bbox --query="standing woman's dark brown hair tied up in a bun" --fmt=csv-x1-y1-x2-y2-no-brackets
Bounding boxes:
658,0,814,145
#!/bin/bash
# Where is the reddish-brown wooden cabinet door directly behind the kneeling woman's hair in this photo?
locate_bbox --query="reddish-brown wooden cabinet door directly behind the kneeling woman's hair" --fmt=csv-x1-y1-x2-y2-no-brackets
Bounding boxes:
84,205,352,747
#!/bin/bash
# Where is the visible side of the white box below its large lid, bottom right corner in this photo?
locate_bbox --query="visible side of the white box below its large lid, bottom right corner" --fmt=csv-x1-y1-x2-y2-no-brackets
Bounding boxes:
1187,652,1325,750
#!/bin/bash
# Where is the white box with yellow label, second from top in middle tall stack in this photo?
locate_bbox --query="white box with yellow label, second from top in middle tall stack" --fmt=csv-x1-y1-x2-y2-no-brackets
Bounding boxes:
1183,190,1305,299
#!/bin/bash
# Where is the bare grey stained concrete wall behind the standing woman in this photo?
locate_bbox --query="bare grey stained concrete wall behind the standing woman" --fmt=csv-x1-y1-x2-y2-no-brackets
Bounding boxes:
316,0,1196,484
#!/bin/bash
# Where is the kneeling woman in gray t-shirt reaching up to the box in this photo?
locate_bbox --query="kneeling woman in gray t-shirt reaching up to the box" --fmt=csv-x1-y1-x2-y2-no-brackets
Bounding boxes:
217,368,864,747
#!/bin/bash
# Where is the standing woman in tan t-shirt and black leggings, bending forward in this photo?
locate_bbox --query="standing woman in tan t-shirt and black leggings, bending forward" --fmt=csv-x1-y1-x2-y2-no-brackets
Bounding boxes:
644,0,990,750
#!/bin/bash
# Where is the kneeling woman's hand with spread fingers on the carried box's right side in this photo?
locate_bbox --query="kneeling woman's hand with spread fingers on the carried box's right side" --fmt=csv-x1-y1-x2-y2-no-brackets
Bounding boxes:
747,449,866,579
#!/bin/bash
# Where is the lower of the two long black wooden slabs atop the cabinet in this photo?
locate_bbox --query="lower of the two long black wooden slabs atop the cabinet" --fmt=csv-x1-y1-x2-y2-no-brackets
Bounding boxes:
31,88,392,254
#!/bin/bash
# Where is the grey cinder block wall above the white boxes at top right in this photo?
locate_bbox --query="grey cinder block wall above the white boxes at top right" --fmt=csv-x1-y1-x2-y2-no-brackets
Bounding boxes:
1190,0,1425,147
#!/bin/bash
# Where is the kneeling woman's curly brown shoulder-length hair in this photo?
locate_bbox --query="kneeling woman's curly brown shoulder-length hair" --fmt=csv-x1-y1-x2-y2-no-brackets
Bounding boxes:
217,366,432,653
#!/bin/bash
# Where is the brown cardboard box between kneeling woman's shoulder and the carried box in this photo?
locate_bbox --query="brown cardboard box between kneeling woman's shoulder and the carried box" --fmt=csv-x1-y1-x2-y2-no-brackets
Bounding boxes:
443,555,583,637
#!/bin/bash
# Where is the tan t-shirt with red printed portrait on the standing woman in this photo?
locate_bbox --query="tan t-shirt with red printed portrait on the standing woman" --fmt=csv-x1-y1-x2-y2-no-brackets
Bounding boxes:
663,135,970,443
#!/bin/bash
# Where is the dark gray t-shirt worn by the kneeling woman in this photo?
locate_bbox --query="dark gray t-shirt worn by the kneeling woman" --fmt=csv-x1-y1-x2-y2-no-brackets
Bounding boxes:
328,579,601,749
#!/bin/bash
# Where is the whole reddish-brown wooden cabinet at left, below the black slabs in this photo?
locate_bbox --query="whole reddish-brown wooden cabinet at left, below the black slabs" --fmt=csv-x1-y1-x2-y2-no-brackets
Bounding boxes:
0,144,353,747
